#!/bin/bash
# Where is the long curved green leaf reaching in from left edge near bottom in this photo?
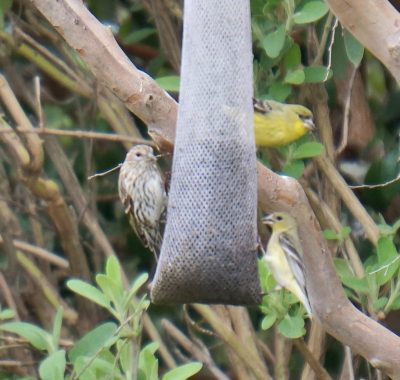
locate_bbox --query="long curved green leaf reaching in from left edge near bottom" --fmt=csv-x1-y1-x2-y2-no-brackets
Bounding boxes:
0,322,53,351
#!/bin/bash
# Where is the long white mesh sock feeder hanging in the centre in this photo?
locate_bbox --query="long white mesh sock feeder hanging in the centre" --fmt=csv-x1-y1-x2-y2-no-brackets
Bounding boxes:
151,0,261,305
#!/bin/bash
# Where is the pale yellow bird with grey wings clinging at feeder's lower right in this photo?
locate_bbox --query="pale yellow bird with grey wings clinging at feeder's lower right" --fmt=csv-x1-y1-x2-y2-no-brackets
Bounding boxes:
262,212,312,317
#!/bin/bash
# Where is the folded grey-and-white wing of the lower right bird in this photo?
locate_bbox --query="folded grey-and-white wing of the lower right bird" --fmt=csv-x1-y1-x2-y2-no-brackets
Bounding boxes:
279,233,307,297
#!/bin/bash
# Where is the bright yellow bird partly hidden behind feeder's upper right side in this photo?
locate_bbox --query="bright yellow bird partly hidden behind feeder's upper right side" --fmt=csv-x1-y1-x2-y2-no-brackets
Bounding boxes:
253,98,315,148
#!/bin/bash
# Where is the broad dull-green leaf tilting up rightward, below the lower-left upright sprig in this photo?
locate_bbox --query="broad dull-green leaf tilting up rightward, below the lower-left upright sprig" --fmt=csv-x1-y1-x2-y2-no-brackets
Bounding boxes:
68,322,118,362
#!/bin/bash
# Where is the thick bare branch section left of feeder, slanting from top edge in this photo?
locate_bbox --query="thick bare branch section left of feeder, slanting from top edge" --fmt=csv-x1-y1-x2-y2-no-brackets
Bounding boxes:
31,0,177,148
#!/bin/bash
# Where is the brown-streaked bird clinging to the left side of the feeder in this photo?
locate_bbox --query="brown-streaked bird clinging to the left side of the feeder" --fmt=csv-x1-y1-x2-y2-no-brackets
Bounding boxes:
118,145,167,261
